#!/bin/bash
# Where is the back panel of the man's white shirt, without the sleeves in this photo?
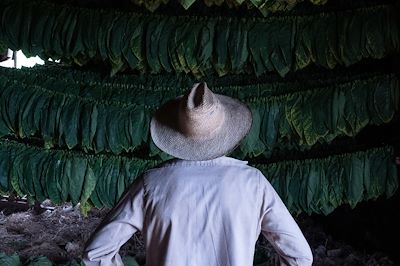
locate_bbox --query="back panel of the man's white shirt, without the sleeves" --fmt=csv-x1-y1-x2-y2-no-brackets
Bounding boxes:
143,157,262,266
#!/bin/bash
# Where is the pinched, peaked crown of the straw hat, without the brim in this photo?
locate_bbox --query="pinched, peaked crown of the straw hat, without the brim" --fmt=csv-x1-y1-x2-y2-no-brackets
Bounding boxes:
179,82,225,139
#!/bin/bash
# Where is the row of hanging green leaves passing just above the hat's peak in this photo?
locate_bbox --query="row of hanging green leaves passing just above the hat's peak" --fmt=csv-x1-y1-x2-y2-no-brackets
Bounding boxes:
0,0,400,77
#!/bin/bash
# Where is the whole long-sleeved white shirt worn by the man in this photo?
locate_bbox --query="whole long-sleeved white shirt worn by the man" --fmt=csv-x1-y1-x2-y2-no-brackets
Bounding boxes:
84,157,313,266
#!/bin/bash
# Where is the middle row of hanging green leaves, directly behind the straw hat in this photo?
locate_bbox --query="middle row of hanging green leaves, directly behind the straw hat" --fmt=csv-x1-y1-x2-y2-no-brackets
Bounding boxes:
0,69,400,158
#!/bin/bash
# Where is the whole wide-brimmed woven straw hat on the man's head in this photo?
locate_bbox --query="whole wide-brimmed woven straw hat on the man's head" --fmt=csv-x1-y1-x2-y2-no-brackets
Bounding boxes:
150,82,252,160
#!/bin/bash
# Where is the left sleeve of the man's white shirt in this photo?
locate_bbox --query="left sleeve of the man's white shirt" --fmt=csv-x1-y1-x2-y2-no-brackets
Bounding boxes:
83,178,144,266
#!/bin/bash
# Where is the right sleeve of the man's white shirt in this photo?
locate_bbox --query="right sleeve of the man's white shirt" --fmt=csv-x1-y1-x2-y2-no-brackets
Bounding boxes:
260,173,313,266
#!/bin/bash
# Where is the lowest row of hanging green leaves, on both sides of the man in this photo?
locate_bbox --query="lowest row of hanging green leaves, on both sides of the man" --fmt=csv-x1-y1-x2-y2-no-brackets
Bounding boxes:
0,140,398,214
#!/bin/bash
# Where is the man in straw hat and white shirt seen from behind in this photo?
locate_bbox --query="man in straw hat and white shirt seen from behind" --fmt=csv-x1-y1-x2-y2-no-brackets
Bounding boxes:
84,83,312,266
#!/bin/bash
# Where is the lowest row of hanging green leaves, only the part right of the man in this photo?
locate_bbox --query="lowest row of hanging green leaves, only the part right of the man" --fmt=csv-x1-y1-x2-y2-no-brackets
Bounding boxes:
256,147,399,215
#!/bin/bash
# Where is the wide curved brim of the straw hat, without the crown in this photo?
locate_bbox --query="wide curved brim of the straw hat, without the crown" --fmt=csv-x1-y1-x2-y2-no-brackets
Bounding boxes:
150,94,252,160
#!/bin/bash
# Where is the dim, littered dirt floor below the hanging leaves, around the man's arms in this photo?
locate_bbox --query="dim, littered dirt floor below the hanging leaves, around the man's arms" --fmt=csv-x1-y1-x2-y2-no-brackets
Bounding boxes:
0,202,395,266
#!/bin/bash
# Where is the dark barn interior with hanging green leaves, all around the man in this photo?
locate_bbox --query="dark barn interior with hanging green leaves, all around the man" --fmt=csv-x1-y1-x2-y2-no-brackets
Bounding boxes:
0,0,400,266
